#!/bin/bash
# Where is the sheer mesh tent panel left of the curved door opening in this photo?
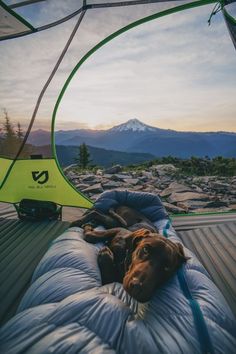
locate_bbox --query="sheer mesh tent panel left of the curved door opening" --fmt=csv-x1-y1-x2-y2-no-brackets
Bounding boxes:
2,2,195,158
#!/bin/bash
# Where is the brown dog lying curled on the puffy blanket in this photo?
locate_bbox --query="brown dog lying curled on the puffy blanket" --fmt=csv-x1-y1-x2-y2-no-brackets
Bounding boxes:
84,225,188,302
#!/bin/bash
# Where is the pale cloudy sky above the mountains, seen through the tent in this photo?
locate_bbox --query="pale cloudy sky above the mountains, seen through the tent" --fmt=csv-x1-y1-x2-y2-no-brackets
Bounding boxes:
0,0,236,132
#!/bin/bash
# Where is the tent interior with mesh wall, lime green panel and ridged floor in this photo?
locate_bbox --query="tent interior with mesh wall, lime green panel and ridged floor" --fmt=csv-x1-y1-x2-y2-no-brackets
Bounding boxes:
0,0,236,340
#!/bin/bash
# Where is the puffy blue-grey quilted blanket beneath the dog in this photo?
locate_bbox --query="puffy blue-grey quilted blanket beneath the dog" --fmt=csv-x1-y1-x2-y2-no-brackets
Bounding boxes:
0,191,236,354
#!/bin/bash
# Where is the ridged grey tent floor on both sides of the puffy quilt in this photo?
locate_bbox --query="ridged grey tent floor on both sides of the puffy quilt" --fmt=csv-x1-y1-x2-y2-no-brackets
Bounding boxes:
0,203,236,324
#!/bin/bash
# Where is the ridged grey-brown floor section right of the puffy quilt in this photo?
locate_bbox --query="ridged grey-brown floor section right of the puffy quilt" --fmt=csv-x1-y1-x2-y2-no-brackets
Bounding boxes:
178,222,236,316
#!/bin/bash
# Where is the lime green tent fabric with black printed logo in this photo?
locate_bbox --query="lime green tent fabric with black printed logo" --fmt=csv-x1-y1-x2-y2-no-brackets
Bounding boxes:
0,159,92,209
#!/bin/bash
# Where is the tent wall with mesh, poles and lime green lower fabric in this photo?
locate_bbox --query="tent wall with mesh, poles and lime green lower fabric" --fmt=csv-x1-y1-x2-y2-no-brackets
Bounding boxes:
0,0,236,208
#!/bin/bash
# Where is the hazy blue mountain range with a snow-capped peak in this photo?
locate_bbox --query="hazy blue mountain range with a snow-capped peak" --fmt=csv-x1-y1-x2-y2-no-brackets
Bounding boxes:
29,119,236,158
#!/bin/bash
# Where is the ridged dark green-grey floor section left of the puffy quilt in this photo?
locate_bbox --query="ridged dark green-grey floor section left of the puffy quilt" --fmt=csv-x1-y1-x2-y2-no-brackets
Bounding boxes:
0,218,69,324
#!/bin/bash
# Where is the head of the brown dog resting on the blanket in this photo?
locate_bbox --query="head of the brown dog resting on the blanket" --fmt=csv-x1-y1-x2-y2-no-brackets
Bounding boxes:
123,230,188,302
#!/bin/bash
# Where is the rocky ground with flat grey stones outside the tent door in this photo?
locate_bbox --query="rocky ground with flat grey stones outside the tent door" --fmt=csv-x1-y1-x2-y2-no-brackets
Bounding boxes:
64,164,236,214
